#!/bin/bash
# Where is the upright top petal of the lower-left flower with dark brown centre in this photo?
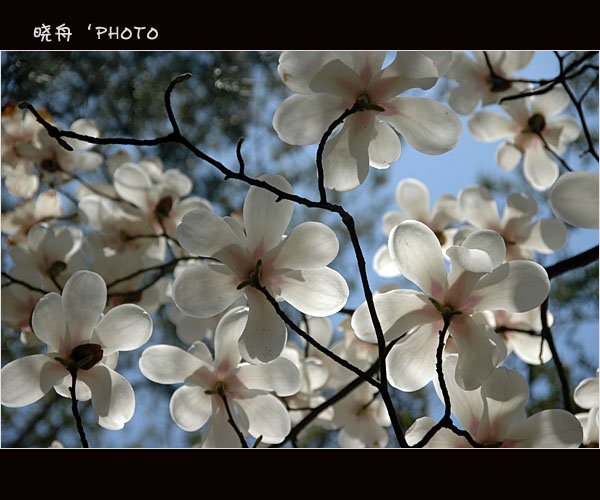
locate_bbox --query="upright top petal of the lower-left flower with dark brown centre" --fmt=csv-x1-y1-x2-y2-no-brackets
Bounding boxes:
62,271,106,347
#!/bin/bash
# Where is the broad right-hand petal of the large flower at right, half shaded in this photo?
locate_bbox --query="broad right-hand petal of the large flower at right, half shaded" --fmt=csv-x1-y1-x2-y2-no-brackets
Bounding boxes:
470,260,550,312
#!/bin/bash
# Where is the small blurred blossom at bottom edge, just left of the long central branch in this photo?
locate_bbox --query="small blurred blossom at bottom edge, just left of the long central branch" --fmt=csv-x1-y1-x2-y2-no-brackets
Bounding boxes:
333,383,392,448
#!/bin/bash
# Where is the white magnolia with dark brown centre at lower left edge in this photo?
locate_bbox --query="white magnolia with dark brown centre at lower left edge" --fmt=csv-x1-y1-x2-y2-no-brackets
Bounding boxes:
2,271,152,430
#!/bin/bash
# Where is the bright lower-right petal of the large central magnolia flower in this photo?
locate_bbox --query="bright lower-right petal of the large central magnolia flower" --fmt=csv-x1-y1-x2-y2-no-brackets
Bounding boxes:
279,267,350,317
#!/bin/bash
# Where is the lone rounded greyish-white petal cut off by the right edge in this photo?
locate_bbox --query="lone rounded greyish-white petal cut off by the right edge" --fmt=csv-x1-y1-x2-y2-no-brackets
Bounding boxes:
550,172,599,229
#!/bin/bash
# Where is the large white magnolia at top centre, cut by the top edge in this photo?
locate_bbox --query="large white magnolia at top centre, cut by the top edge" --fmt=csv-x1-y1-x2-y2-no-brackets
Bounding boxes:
273,51,462,191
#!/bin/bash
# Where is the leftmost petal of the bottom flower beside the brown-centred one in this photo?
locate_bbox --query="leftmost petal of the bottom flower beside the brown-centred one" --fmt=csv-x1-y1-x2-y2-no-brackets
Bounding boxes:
139,345,212,388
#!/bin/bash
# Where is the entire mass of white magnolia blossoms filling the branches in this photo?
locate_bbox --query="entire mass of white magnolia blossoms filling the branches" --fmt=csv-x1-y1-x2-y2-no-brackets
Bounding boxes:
1,51,598,448
